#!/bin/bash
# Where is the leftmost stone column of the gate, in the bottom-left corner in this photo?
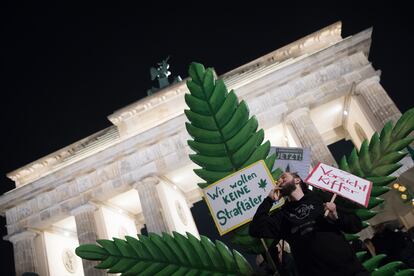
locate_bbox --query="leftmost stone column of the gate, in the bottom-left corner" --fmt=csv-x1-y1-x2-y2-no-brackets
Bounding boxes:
8,230,39,276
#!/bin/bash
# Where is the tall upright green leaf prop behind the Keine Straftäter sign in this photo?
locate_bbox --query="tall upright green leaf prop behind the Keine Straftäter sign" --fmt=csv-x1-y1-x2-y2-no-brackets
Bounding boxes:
185,63,281,253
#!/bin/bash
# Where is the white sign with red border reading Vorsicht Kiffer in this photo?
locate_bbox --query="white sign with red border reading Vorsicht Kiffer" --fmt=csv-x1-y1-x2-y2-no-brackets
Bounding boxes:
305,163,372,207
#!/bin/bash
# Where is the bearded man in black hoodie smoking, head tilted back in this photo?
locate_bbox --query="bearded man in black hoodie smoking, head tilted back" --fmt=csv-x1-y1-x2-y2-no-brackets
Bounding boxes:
249,172,370,276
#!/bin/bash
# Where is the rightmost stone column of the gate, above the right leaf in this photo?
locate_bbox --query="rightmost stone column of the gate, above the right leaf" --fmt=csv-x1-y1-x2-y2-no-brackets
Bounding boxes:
356,76,401,131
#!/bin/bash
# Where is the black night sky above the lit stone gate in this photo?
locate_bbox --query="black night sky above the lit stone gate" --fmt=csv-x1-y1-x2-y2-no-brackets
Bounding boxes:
0,1,414,275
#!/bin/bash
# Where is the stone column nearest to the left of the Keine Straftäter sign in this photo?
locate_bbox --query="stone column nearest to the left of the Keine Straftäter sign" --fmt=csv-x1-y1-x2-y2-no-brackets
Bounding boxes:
133,177,168,234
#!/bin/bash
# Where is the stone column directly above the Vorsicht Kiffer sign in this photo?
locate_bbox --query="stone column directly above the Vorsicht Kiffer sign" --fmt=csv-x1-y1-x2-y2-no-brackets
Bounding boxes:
285,107,336,167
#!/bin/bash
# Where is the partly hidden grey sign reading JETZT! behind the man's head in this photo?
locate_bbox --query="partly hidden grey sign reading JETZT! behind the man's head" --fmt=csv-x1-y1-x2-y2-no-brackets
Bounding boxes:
269,147,311,179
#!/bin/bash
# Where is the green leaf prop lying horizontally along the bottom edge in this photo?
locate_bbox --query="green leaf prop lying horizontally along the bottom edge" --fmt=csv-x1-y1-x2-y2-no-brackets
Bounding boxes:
76,232,253,276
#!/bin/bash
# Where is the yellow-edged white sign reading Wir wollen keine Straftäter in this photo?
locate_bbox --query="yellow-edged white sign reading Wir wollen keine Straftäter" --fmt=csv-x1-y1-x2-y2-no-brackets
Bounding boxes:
203,160,274,235
